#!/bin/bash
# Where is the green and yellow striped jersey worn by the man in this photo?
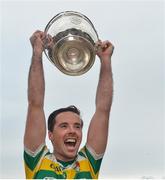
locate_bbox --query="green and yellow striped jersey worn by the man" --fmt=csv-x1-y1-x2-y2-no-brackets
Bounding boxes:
24,145,103,179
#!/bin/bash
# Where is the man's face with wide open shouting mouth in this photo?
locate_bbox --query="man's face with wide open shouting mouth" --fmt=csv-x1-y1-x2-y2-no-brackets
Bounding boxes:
49,111,82,161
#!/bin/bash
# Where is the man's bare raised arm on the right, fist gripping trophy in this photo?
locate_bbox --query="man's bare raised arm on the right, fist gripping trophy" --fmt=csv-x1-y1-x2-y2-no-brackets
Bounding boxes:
87,41,114,154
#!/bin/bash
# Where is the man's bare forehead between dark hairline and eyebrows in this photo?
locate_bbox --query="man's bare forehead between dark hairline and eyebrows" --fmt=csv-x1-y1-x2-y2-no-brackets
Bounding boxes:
56,111,81,124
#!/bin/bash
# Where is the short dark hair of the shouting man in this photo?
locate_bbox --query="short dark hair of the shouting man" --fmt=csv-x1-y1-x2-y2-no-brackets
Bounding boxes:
48,105,83,132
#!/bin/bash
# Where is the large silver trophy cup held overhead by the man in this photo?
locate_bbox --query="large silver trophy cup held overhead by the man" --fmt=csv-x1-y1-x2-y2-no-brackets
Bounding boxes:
44,11,99,76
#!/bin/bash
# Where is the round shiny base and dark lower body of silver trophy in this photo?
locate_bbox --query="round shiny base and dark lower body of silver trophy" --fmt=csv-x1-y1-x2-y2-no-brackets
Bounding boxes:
48,28,95,76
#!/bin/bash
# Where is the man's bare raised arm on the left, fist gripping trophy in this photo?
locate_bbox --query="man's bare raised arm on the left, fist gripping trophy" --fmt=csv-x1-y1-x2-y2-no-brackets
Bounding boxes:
24,31,50,152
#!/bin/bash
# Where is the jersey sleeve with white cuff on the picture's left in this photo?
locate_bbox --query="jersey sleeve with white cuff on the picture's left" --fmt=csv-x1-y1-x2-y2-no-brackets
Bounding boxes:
24,144,49,179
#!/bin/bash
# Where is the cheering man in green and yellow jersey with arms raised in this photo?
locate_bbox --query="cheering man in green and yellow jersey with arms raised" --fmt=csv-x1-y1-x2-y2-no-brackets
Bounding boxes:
24,31,114,179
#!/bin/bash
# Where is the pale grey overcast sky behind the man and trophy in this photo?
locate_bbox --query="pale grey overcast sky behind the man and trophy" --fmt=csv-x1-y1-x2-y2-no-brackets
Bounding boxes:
0,0,165,179
